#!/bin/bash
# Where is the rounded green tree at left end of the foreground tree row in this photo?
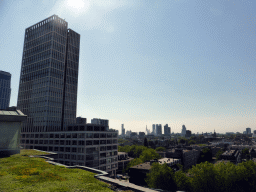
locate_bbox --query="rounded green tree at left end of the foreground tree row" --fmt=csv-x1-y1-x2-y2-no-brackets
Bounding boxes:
145,163,177,191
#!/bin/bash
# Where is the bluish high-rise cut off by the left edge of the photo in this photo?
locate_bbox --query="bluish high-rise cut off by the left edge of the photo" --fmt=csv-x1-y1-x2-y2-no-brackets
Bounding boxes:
0,71,11,109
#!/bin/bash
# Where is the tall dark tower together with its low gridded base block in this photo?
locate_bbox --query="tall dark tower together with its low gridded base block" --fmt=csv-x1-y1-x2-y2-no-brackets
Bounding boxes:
17,15,118,176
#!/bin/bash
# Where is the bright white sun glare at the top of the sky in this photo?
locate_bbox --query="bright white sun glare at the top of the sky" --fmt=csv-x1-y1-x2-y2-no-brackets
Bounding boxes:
67,0,90,13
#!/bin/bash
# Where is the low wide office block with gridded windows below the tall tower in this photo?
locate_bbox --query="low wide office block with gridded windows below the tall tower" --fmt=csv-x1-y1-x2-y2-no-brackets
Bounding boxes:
20,124,118,176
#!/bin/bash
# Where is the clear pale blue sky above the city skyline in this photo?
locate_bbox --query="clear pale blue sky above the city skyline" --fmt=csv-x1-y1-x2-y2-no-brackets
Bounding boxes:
0,0,256,133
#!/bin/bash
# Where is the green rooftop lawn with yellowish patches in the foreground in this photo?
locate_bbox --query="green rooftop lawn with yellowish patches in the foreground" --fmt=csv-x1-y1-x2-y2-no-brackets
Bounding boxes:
0,150,112,192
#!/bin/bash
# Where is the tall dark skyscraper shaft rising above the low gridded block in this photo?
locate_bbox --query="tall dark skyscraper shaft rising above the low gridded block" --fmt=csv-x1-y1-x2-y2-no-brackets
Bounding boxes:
17,15,80,132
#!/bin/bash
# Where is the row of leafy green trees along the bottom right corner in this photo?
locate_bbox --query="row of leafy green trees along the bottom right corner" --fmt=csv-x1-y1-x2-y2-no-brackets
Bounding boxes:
146,160,256,192
